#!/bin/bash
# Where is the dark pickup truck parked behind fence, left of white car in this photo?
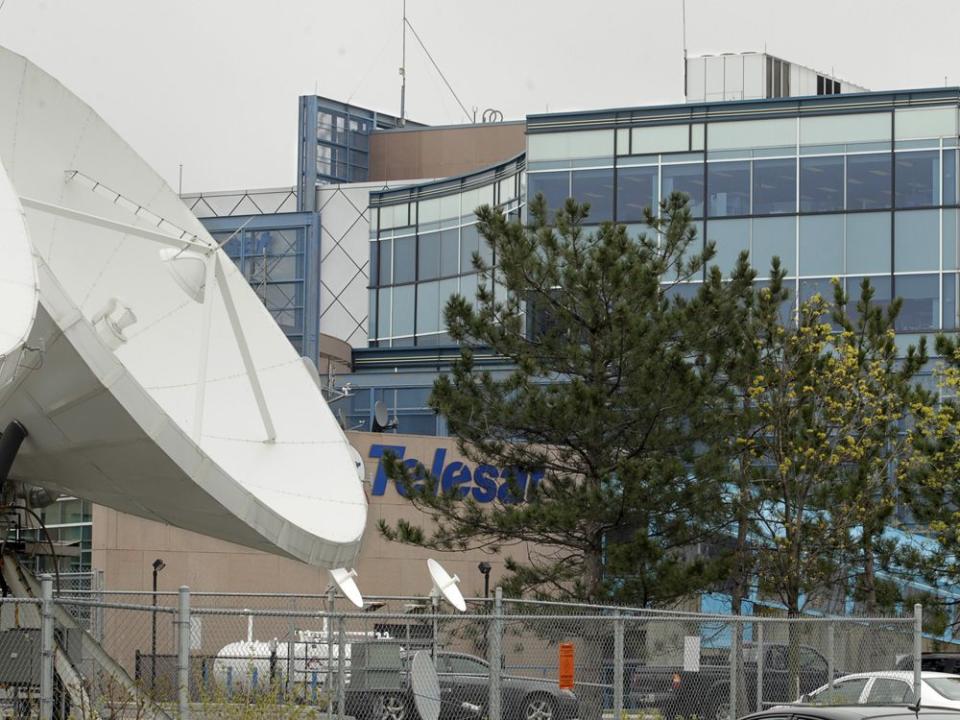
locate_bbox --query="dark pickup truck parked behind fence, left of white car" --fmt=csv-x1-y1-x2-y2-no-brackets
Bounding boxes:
624,643,839,720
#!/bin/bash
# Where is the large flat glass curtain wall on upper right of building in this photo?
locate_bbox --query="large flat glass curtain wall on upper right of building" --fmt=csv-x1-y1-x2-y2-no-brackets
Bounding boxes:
527,104,958,332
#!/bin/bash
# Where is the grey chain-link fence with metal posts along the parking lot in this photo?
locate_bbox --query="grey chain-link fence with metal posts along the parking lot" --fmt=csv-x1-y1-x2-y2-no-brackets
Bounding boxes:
11,580,920,720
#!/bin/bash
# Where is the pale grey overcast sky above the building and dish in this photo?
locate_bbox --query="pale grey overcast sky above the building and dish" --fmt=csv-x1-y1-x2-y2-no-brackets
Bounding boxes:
0,0,960,192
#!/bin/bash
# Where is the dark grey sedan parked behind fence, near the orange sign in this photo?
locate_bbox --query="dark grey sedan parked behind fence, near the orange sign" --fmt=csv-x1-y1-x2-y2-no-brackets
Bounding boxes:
346,652,579,720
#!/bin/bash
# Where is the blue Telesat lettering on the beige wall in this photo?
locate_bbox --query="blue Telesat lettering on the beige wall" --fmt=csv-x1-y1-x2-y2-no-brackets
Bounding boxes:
370,445,543,504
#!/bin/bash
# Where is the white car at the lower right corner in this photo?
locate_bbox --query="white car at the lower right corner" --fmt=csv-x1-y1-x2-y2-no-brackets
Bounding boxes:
801,670,960,710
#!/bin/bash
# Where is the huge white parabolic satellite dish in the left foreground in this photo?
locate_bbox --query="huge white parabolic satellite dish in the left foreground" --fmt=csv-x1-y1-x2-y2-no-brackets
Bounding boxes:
0,48,367,567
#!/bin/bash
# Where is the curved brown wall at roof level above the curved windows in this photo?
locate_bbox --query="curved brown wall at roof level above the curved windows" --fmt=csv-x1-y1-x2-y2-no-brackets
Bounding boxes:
370,121,526,180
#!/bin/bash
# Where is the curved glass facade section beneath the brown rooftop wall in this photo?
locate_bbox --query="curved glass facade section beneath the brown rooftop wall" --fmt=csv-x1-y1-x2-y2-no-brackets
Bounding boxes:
369,161,523,347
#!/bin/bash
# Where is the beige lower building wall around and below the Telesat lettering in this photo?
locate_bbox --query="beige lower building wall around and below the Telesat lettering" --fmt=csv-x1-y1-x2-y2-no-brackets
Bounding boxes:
92,432,522,596
